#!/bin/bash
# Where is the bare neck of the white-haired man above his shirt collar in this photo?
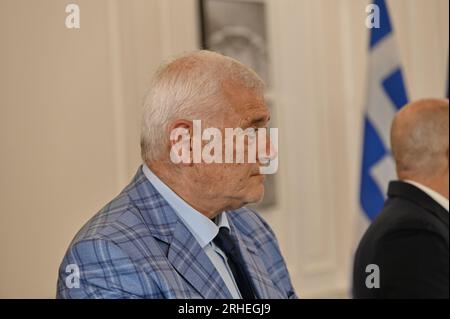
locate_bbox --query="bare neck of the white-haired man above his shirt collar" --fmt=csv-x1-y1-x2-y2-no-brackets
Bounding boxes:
146,162,225,219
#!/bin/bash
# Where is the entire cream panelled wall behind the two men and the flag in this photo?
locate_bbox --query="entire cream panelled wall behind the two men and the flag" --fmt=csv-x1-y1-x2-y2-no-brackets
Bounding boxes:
0,0,448,298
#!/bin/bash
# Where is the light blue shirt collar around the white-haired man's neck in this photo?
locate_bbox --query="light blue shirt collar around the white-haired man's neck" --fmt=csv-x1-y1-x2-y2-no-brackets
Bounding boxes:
142,164,230,248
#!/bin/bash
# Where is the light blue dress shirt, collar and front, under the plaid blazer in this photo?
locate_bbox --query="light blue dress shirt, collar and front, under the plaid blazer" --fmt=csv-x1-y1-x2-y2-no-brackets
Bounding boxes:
142,164,242,299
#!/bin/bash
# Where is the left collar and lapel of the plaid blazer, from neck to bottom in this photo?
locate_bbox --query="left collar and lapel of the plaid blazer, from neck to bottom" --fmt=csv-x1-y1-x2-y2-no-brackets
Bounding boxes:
126,168,232,299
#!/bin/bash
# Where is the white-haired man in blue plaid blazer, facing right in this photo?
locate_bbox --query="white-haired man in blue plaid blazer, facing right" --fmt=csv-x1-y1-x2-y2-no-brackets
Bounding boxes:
57,51,296,299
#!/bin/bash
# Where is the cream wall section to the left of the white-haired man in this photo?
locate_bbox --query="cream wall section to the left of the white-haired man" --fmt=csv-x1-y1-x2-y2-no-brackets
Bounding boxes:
0,0,197,298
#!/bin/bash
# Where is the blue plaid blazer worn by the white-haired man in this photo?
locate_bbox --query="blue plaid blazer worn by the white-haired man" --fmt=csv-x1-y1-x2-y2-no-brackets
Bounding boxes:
57,168,296,299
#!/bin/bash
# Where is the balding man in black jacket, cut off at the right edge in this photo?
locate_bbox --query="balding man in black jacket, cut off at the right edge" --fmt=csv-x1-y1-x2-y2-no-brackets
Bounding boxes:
353,99,449,298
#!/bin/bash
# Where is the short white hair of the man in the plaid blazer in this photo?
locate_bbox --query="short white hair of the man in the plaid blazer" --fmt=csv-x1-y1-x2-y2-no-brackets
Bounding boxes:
141,50,264,162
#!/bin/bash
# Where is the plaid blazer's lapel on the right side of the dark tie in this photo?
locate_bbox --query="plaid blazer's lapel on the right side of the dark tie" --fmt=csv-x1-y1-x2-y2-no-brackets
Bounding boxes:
230,225,286,299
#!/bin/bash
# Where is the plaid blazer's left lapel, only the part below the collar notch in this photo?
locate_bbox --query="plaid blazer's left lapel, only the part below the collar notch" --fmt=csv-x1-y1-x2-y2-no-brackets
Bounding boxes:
167,220,232,299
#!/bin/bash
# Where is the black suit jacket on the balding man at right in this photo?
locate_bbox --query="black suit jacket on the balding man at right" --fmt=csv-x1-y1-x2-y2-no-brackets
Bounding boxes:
353,181,449,298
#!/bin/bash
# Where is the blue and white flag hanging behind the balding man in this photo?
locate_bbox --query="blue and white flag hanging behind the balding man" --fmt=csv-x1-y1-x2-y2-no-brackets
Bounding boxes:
360,0,408,220
